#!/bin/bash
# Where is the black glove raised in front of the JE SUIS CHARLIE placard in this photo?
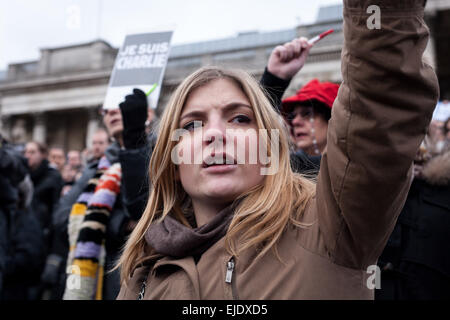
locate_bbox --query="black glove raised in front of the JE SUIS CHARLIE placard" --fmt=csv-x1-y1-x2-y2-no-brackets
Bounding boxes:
119,89,148,149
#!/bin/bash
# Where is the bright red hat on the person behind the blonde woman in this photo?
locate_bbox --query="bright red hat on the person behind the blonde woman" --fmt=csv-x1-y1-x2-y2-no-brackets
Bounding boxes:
281,79,339,110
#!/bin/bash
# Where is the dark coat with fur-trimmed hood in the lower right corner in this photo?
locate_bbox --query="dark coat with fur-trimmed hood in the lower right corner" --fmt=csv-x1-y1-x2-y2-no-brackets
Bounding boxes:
376,151,450,300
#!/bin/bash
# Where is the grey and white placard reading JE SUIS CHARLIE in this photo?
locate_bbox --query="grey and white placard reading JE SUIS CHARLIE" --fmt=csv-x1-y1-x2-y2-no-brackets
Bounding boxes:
103,31,173,109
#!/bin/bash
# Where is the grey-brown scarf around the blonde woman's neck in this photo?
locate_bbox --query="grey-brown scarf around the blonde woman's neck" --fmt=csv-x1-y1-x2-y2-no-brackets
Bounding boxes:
145,205,235,258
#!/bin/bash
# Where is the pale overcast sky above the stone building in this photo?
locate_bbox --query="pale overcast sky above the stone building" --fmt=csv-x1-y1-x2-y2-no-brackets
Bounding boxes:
0,0,340,70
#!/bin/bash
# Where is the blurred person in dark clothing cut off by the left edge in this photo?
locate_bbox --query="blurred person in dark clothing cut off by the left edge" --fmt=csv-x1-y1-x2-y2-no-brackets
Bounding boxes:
0,141,44,300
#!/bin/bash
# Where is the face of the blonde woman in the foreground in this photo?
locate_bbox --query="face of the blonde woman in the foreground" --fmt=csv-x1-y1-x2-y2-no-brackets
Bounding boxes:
178,79,264,205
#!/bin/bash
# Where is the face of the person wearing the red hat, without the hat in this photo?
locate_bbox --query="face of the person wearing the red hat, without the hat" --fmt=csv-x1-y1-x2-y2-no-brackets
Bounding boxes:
290,106,328,155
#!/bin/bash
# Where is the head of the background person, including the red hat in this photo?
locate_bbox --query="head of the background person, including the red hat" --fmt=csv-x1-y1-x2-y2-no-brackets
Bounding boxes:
282,79,339,155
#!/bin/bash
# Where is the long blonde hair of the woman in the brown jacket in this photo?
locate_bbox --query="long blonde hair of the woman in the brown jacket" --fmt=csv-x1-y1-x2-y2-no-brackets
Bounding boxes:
117,67,315,284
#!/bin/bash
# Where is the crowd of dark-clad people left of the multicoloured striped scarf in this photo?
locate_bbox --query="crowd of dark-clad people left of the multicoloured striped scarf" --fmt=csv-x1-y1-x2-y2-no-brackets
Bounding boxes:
1,129,109,300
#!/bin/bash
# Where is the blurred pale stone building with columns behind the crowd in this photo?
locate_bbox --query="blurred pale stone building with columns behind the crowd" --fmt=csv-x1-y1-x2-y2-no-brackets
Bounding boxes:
0,0,450,151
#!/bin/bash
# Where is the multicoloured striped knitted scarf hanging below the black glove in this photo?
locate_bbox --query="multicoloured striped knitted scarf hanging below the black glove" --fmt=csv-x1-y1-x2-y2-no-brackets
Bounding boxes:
63,157,122,300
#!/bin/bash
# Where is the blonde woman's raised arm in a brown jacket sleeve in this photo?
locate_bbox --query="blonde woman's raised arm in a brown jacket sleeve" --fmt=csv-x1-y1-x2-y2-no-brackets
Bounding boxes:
316,0,438,269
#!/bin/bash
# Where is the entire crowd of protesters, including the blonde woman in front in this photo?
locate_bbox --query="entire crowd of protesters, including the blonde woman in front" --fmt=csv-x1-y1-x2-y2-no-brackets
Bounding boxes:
0,0,450,300
